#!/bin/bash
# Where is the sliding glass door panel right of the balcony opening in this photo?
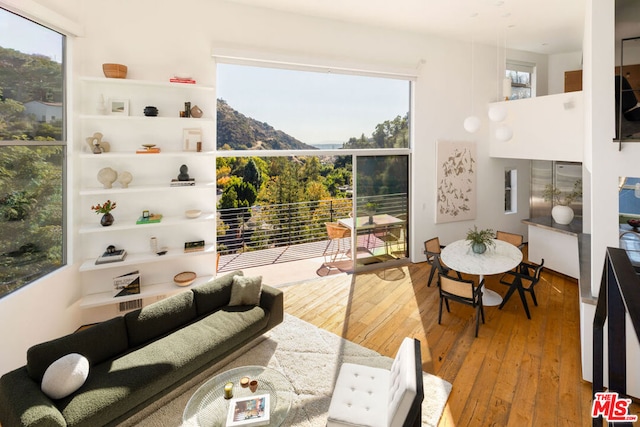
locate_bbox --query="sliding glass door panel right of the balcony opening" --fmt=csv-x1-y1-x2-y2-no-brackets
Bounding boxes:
352,155,409,269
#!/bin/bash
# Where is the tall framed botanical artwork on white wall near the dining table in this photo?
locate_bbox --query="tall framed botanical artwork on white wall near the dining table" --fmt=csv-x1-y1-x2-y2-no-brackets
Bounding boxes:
436,141,477,223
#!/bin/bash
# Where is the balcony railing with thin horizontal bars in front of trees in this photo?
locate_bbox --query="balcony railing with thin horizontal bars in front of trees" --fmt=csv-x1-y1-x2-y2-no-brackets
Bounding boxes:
217,193,407,259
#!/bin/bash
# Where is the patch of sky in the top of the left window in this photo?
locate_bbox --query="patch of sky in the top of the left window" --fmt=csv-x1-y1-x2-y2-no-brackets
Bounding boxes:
0,9,62,62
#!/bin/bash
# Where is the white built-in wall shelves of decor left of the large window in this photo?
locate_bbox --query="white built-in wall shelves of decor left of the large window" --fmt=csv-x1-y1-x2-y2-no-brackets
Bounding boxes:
73,78,216,308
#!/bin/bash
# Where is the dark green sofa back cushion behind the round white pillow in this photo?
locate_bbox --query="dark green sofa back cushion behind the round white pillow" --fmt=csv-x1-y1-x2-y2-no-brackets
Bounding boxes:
27,316,129,384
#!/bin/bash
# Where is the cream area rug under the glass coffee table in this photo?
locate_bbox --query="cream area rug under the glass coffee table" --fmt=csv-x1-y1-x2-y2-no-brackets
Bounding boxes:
122,314,451,427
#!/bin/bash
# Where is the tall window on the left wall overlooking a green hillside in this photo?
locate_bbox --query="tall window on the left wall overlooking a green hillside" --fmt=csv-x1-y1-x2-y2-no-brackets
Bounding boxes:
0,8,66,297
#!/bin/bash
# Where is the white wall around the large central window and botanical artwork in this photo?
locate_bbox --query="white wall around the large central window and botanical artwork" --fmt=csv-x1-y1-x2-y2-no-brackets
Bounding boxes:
0,0,584,373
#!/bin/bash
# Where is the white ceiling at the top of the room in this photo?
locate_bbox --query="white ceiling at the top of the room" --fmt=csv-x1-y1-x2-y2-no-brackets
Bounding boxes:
222,0,585,54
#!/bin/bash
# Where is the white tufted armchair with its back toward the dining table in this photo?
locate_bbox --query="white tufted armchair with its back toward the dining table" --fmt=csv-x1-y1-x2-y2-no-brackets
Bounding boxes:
327,338,424,427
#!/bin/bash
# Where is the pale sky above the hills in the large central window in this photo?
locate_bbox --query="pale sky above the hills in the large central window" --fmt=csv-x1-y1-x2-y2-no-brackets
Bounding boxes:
216,64,410,145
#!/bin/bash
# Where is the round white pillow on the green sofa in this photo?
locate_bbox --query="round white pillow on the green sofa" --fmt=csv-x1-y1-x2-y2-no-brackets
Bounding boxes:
40,353,89,399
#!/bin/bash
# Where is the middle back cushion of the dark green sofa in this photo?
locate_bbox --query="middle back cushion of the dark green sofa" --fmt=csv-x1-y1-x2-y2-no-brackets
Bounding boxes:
124,292,196,347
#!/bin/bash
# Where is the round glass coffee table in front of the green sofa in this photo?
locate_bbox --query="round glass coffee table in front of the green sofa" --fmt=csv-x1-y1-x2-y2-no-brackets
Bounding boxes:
182,366,293,427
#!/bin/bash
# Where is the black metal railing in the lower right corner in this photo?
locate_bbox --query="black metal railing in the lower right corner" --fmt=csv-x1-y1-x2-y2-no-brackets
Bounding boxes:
592,248,640,426
